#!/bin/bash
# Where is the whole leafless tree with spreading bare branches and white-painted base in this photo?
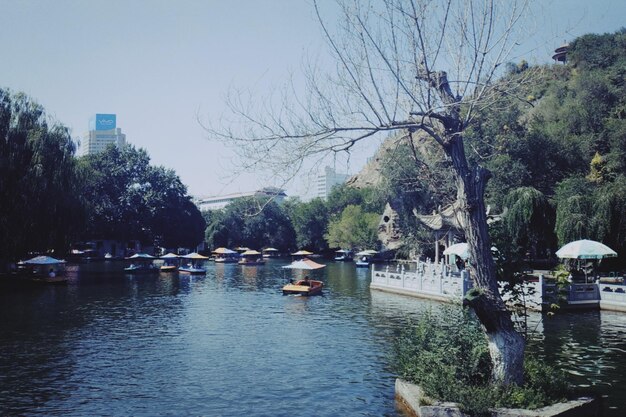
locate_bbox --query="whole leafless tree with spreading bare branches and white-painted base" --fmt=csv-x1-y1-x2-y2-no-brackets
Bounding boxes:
208,0,530,384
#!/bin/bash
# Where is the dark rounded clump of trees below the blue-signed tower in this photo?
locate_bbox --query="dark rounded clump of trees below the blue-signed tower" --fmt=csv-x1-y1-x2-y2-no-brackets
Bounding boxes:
81,145,206,248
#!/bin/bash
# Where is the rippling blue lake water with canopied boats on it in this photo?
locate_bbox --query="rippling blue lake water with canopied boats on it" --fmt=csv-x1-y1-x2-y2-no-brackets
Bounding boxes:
0,261,626,416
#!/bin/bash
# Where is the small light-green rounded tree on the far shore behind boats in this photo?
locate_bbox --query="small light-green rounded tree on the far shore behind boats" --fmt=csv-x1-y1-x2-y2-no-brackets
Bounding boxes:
326,205,380,249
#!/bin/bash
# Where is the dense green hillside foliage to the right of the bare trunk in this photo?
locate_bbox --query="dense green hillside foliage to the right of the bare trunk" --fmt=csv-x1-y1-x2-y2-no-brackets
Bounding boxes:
456,30,626,264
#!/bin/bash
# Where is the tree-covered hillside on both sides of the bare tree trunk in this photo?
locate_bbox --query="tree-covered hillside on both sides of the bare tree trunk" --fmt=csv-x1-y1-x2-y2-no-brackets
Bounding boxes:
209,30,626,265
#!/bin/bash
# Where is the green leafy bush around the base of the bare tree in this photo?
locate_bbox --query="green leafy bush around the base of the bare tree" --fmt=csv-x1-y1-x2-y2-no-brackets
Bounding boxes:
394,307,569,416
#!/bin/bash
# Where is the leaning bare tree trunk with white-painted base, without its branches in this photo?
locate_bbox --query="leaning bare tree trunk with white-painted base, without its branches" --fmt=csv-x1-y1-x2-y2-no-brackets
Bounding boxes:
444,134,525,385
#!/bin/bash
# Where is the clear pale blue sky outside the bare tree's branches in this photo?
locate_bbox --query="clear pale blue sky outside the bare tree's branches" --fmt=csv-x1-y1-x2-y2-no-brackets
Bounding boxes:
0,0,626,198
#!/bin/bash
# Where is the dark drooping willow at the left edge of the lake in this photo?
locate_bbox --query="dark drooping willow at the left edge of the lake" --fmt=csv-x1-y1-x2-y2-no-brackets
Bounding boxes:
0,89,84,260
